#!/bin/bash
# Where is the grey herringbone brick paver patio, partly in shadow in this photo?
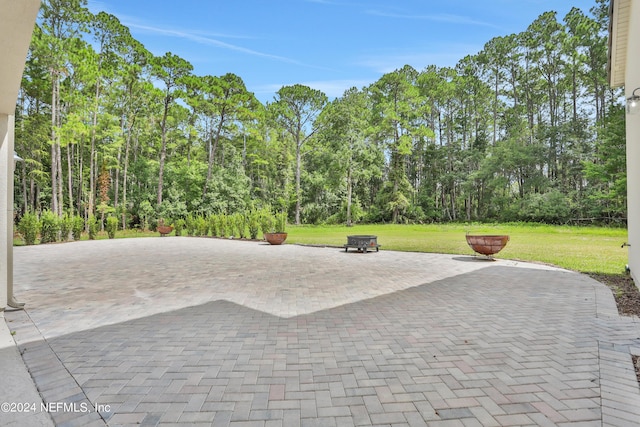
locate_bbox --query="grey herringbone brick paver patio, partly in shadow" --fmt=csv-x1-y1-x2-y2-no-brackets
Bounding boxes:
0,237,640,427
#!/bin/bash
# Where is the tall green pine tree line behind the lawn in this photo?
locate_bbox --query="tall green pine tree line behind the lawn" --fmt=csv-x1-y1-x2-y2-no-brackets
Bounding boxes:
15,0,626,228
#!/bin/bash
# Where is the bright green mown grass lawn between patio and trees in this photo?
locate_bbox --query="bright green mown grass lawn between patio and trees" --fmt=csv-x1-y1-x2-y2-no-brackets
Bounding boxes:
15,223,627,274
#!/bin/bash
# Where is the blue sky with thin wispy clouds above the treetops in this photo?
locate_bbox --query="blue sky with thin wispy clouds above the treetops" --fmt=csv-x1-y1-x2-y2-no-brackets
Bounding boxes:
88,0,595,102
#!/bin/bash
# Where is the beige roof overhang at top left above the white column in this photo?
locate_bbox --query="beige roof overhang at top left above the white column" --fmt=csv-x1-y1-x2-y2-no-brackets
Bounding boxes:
0,0,40,115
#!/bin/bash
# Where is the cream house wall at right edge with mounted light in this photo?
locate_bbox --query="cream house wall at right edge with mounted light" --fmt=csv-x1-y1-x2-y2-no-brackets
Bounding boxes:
625,2,640,287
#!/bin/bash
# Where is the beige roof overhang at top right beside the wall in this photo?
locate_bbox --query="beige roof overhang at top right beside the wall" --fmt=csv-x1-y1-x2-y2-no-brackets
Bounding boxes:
607,0,637,87
